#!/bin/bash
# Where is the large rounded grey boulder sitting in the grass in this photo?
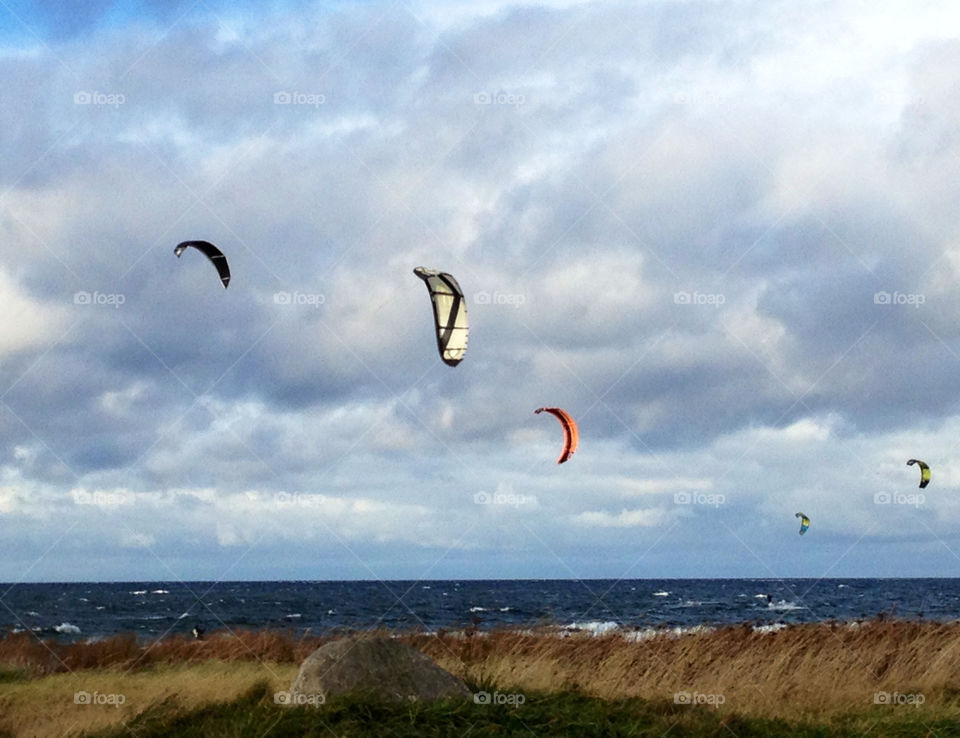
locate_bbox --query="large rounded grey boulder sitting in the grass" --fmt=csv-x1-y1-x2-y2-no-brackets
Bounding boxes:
290,638,471,701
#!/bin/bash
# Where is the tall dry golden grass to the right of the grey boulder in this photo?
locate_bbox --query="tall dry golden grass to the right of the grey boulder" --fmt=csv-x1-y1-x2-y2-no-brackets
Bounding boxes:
410,621,960,718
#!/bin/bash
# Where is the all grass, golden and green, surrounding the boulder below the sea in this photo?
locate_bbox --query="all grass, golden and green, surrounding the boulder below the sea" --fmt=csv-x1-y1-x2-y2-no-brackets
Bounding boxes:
0,621,960,738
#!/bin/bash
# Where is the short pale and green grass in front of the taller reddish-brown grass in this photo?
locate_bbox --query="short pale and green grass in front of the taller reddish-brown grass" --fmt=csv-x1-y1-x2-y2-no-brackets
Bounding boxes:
0,663,960,738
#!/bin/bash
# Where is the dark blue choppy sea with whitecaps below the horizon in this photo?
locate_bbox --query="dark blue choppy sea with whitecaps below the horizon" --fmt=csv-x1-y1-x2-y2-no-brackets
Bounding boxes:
0,579,960,641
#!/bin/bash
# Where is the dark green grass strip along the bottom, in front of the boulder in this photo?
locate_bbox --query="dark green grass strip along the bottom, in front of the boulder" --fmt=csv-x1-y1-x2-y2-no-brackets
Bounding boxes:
88,683,960,738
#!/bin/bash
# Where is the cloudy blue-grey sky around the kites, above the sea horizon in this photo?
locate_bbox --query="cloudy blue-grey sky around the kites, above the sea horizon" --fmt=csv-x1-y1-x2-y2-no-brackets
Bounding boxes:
0,0,960,582
